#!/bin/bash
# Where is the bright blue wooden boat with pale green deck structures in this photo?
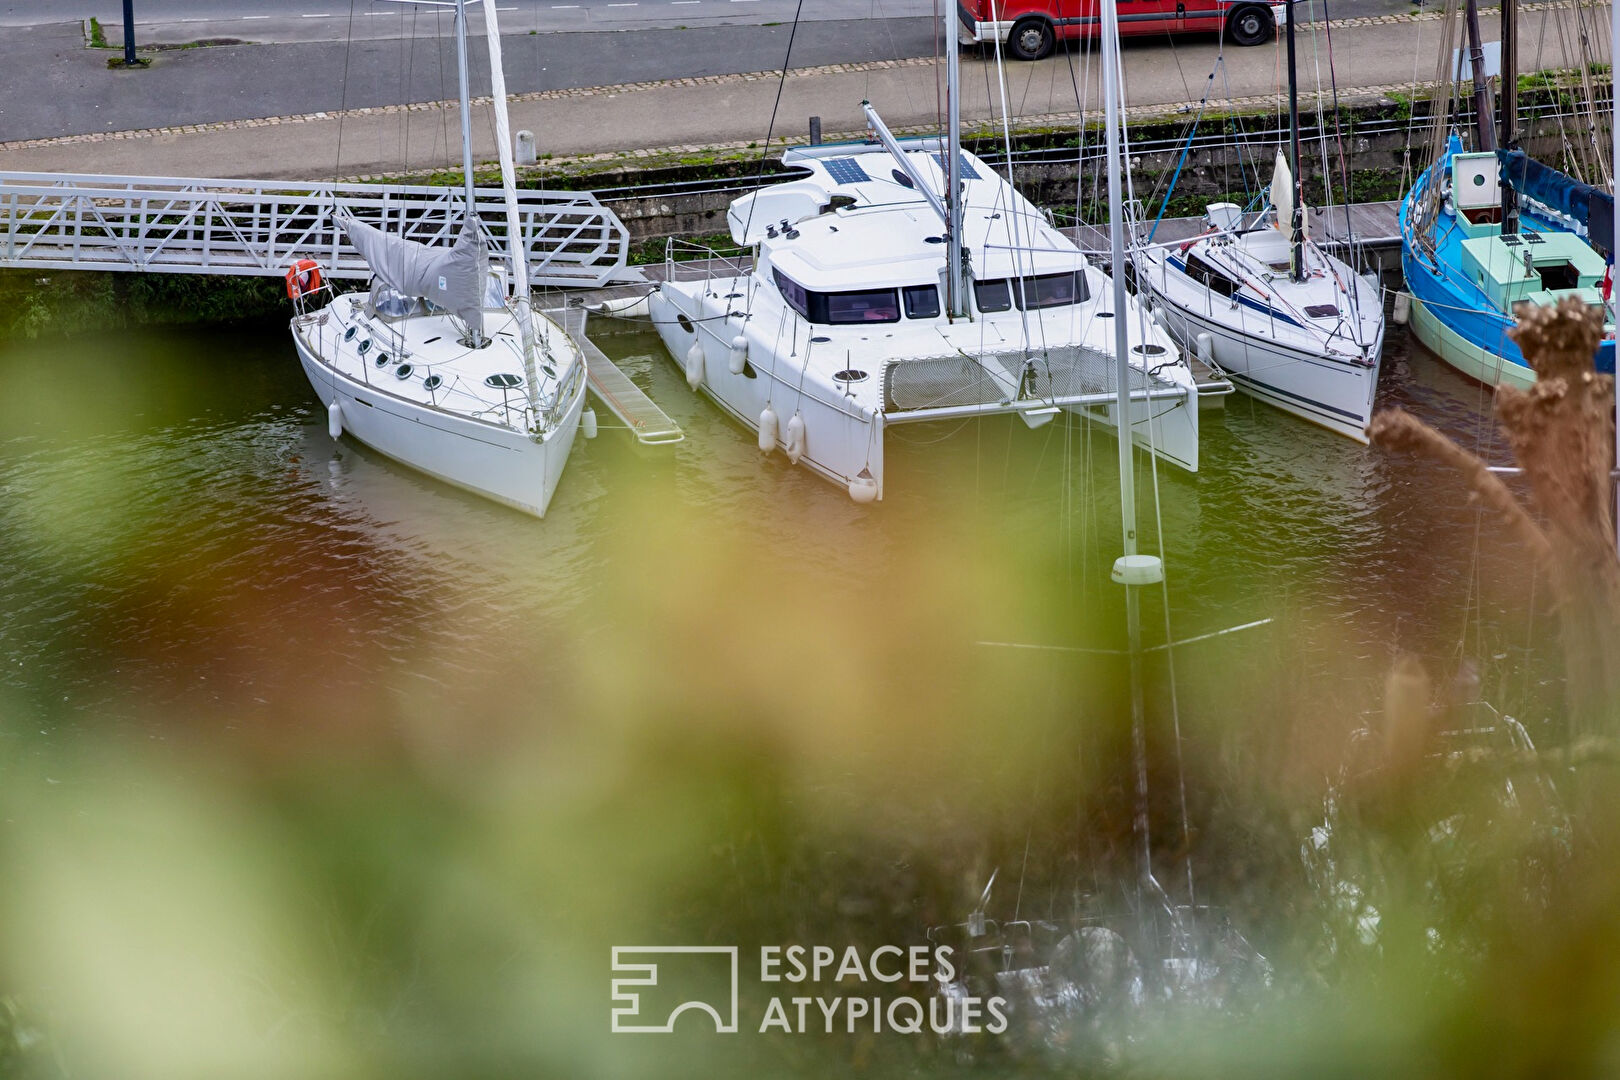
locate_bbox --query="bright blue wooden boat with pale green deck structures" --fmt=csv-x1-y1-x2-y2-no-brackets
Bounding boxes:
1400,0,1615,387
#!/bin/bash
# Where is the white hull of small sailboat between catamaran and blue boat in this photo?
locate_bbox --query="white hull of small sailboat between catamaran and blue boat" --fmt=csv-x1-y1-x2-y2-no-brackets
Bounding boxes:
1158,296,1383,444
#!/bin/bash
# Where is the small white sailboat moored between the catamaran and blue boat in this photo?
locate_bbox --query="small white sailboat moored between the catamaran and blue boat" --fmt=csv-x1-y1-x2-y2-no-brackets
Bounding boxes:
1136,5,1383,442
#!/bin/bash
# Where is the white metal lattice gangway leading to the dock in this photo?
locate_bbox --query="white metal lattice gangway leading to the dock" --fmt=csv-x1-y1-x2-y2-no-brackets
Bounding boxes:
0,172,630,288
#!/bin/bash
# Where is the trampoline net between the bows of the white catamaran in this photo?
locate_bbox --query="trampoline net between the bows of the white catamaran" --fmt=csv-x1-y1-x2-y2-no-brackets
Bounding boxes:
883,345,1173,411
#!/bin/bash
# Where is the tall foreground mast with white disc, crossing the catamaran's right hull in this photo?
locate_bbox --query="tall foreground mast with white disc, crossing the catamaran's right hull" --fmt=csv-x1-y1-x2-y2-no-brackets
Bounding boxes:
1098,0,1153,882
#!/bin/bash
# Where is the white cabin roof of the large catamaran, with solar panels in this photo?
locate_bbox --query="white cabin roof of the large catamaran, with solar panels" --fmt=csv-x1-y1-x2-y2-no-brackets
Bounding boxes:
748,139,1087,291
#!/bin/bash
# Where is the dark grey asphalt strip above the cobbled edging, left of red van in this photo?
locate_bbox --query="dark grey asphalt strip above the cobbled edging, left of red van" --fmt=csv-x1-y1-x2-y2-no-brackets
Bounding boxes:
0,18,938,142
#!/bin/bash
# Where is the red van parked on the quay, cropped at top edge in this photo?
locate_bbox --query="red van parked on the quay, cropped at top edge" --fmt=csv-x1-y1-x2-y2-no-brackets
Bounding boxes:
956,0,1288,60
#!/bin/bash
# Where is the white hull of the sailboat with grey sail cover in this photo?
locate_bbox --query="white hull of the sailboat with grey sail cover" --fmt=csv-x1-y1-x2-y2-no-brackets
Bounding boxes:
293,332,585,518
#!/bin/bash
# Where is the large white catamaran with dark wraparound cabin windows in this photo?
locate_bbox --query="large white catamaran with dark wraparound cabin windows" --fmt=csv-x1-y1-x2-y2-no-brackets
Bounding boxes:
648,7,1199,502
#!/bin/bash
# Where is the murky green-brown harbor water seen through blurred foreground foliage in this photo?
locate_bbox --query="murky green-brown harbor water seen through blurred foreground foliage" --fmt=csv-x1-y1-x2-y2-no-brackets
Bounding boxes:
0,310,1594,1077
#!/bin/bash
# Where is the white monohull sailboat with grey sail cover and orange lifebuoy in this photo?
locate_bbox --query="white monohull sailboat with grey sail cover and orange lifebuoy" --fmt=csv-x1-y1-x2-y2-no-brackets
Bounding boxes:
288,0,586,517
